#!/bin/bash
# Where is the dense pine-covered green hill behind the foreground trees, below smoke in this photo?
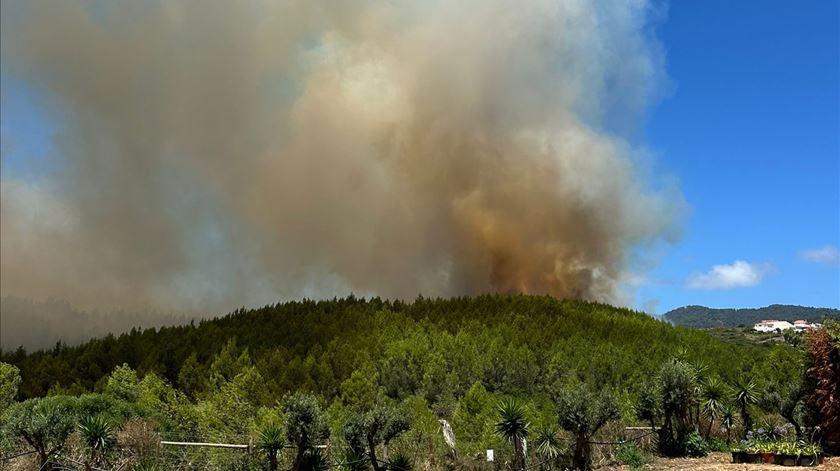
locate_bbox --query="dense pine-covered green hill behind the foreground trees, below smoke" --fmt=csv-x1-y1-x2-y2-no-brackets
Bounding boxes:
2,295,784,407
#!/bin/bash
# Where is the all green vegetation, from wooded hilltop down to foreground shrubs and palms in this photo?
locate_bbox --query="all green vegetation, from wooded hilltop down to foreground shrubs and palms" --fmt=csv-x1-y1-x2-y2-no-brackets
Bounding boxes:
0,296,840,471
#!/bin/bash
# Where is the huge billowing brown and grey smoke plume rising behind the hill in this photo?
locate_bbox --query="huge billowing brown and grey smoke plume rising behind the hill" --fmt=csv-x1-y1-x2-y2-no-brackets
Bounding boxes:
2,0,676,318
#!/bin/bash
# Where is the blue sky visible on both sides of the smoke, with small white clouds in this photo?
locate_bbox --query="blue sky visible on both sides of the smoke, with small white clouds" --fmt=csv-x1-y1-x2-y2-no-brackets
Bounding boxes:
0,0,840,313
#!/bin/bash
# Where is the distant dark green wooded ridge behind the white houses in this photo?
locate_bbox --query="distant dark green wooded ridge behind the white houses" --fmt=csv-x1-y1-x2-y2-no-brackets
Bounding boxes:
664,304,840,328
